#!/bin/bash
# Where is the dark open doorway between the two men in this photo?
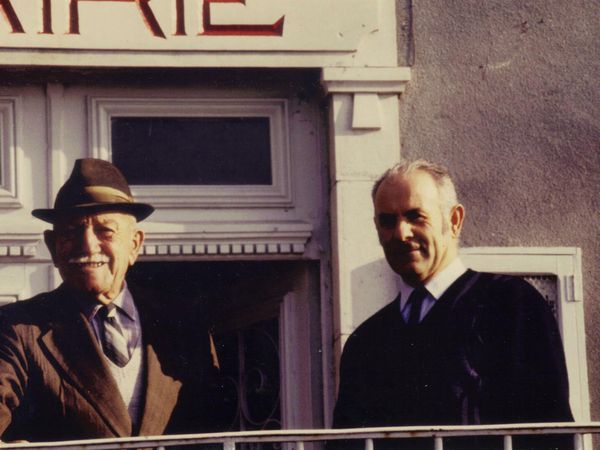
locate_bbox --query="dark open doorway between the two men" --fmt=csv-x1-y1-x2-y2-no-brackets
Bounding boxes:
128,261,323,431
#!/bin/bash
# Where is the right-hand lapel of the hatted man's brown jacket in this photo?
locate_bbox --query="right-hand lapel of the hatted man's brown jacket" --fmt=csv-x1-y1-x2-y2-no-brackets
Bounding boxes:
132,291,181,436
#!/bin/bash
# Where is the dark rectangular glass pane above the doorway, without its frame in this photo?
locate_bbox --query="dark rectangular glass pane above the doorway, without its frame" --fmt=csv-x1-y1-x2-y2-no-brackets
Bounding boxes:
111,117,272,185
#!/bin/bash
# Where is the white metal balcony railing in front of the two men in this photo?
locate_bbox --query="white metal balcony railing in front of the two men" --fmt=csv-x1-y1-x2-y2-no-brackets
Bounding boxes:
1,422,600,450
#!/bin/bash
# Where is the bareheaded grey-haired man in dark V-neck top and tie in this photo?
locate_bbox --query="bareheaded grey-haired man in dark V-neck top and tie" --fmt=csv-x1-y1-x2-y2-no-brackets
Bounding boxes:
334,160,573,448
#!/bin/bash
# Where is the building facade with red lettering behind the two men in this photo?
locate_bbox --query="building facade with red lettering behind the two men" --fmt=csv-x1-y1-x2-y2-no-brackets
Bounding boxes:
0,0,600,442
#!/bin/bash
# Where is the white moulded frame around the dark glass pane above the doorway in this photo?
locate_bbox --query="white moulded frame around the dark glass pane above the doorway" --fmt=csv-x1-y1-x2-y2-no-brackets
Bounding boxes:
88,97,294,209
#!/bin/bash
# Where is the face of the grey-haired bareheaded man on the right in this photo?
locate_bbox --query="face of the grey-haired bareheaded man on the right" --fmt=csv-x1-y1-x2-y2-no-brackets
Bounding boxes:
374,170,464,286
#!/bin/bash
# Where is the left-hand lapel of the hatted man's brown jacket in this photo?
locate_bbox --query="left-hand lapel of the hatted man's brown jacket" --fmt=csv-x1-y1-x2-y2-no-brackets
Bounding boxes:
41,289,132,437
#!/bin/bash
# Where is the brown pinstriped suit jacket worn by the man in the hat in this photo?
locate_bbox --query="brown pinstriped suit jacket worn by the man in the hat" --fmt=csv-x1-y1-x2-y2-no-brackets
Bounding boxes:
0,286,223,441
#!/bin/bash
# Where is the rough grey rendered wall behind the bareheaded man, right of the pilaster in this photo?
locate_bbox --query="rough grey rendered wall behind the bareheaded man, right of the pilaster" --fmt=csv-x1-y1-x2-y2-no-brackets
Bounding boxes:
397,0,600,420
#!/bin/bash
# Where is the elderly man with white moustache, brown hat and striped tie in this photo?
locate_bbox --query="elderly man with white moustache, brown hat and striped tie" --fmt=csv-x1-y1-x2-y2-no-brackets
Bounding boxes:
0,159,218,441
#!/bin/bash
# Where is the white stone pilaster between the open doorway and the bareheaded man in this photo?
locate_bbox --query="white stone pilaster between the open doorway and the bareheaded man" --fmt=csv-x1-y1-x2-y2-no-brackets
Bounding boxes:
322,67,410,373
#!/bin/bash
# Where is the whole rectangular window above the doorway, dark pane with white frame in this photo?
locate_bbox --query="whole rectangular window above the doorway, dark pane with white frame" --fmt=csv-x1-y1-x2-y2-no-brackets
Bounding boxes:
89,97,293,208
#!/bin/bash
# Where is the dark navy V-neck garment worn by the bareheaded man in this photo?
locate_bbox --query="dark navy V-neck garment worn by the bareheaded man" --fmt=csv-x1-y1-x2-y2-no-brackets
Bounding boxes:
334,270,572,448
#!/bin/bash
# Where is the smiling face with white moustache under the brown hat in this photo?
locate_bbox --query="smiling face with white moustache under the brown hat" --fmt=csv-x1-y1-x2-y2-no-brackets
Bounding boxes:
44,212,144,304
